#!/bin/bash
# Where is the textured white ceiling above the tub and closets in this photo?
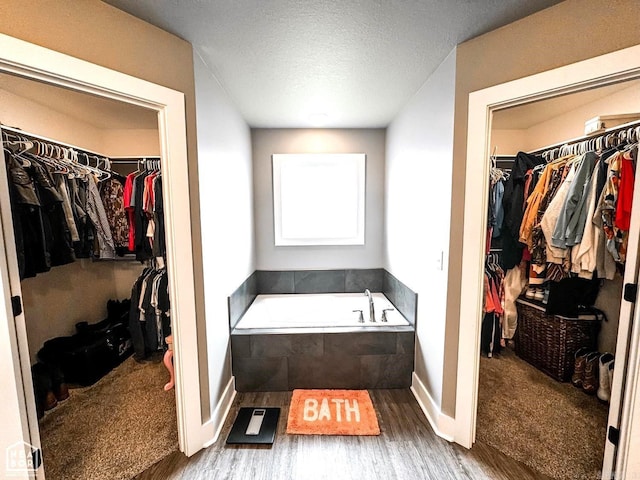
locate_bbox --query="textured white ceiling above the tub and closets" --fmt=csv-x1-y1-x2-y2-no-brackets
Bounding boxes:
106,0,558,128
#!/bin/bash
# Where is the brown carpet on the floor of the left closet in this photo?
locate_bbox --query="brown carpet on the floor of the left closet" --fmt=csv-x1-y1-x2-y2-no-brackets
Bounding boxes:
40,358,178,480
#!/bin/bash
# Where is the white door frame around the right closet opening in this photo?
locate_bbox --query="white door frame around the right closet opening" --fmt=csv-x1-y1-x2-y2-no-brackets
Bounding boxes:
454,45,640,479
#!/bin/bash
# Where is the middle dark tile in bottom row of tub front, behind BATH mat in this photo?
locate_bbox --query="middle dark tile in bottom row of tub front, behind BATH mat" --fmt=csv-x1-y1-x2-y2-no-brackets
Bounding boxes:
289,355,362,390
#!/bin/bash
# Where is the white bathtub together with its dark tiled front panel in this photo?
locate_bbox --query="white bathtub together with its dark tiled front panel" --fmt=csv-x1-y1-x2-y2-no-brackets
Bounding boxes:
231,293,415,392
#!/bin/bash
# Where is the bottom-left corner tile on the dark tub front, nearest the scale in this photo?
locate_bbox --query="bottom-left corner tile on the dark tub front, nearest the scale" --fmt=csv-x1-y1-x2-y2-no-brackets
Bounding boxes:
232,358,288,392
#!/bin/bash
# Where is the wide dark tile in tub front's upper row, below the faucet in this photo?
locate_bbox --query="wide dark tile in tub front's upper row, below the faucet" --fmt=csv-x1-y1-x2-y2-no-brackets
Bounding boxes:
324,332,397,355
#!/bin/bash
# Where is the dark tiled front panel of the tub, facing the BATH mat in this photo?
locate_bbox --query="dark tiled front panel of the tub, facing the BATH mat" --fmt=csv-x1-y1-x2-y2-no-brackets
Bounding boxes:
231,325,415,392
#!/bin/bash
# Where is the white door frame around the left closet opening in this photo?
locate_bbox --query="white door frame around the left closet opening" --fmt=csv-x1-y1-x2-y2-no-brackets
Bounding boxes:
0,34,210,462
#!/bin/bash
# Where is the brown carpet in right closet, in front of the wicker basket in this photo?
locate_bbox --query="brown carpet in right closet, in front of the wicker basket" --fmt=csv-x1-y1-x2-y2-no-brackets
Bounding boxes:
476,349,608,480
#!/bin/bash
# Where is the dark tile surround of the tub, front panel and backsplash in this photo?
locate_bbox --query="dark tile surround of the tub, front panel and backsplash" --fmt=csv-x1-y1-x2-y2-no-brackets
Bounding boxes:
229,269,417,392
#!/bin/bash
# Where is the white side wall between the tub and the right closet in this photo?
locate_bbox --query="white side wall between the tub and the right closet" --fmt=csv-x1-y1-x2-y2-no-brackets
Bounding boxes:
385,50,456,409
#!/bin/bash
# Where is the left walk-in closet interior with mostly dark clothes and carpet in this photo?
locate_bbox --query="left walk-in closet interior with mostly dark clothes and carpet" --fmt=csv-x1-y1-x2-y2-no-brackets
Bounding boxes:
0,74,178,480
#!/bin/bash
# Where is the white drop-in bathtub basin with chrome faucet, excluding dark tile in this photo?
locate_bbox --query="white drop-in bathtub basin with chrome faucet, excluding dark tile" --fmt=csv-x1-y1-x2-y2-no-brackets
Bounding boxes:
235,293,409,330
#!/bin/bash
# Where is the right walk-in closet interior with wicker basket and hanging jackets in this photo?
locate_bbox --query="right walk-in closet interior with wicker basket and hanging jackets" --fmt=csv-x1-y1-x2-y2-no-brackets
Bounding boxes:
476,77,640,479
